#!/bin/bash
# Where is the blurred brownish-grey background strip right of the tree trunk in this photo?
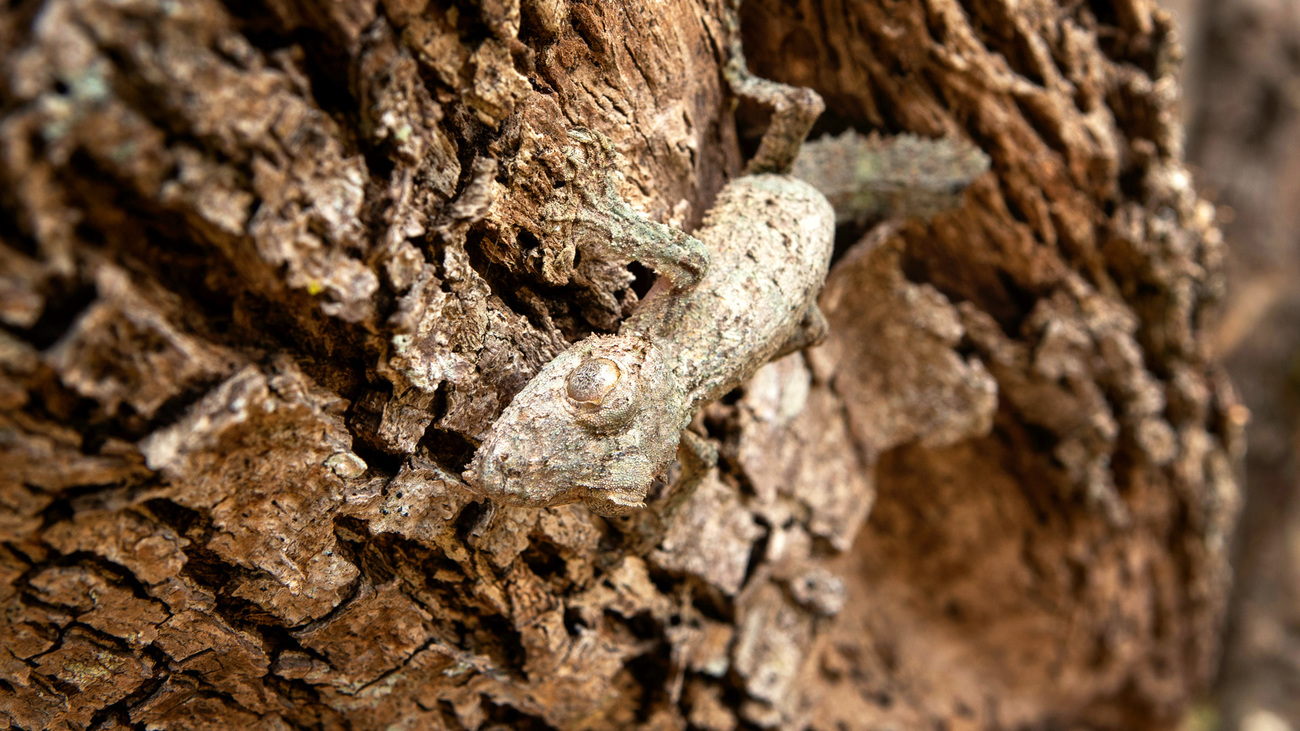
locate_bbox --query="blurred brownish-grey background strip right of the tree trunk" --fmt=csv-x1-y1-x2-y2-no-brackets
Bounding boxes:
1185,0,1300,731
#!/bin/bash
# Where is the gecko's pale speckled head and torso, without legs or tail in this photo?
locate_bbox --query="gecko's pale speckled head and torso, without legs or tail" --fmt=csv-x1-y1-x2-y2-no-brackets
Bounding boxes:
464,174,835,515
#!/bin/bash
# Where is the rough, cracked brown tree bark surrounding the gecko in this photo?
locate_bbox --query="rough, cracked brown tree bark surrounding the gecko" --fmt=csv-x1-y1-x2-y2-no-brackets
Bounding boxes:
0,0,1243,730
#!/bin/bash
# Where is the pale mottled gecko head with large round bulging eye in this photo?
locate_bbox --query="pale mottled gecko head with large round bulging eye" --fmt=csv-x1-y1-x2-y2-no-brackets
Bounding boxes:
464,336,689,515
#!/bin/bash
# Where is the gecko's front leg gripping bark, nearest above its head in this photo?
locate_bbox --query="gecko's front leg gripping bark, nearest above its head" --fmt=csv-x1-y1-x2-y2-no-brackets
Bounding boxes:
542,129,709,290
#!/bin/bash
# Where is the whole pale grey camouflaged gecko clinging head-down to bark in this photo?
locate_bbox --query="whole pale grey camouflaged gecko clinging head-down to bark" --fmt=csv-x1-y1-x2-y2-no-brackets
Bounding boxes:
463,36,987,516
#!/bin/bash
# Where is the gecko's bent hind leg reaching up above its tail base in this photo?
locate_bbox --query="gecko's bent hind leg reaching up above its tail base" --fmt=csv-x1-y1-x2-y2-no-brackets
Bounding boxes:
723,0,826,174
